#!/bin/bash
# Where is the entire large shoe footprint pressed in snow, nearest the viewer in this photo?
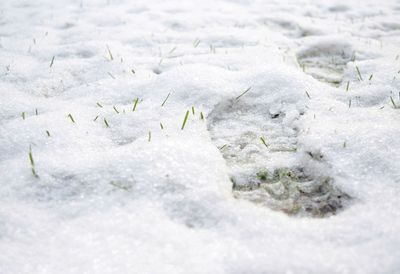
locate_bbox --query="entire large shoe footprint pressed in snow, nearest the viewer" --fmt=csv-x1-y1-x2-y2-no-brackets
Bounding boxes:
207,97,350,217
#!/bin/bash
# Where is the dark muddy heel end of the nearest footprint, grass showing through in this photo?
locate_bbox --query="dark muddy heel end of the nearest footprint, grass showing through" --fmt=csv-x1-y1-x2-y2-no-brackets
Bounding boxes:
232,168,350,217
